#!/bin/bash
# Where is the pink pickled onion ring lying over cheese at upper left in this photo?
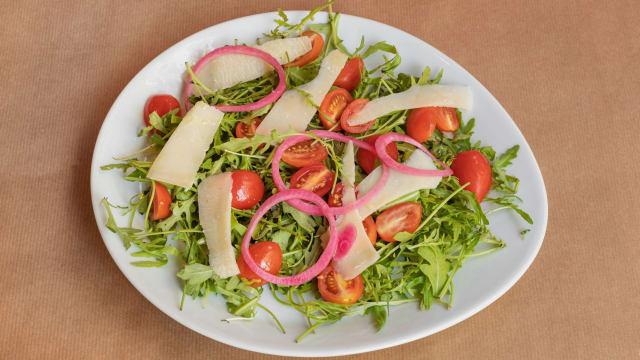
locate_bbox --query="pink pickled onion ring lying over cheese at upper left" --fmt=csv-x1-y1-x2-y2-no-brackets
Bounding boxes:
182,45,287,112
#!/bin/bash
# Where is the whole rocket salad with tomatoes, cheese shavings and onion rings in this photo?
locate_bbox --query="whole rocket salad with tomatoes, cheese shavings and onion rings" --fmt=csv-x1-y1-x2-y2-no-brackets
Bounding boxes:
102,1,533,341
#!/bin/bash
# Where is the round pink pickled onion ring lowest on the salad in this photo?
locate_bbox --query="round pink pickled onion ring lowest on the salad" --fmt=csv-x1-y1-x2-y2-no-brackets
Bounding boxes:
240,189,338,286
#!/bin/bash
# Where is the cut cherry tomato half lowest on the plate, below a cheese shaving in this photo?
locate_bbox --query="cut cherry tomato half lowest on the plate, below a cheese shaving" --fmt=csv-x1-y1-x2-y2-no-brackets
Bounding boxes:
318,264,364,304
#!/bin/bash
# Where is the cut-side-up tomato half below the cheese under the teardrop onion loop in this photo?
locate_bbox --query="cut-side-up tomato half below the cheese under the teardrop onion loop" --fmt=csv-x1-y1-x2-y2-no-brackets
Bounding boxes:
376,202,422,242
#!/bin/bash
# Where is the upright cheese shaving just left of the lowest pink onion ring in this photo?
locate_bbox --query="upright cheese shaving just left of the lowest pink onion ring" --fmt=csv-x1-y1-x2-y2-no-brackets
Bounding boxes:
198,172,240,279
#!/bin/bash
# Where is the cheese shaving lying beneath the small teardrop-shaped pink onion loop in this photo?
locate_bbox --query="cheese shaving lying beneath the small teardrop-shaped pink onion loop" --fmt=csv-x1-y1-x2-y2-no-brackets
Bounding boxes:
358,150,442,219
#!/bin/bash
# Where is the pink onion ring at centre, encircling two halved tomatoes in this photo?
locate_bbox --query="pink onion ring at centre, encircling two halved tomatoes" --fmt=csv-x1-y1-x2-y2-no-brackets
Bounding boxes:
271,130,389,216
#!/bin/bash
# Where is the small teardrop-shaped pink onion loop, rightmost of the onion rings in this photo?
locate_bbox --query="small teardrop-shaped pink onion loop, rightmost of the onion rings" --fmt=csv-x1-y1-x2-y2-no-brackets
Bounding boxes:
375,133,453,176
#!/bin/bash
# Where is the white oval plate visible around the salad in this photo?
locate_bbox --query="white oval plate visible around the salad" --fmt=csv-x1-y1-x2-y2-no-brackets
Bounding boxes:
91,11,547,356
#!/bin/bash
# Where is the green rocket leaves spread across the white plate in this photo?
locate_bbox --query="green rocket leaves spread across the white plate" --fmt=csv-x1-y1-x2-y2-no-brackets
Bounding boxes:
102,1,533,341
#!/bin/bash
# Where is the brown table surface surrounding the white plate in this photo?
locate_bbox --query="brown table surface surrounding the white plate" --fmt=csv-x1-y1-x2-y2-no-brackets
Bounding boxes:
0,0,640,359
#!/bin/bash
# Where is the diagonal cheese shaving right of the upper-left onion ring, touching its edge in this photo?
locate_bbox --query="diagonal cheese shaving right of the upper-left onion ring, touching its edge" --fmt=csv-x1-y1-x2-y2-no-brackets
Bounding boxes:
256,50,347,135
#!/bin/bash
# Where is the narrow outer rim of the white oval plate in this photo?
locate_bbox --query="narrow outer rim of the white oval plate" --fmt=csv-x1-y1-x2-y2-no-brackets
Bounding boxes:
89,10,549,357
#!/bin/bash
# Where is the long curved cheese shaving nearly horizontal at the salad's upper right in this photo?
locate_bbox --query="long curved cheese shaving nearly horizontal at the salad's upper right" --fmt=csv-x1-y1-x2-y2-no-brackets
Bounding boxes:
349,85,472,126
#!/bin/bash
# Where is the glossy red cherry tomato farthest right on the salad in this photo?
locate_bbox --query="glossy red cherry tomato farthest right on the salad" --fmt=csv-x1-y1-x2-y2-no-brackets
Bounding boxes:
451,150,491,202
